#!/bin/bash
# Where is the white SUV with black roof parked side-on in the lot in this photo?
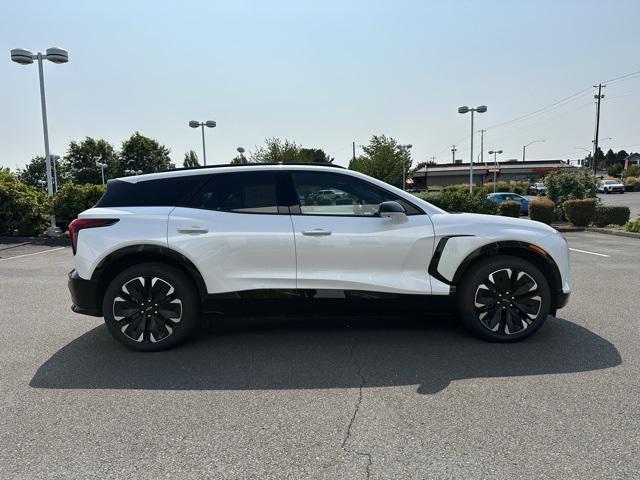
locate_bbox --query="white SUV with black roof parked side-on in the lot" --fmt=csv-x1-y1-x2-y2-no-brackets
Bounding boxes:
69,164,571,350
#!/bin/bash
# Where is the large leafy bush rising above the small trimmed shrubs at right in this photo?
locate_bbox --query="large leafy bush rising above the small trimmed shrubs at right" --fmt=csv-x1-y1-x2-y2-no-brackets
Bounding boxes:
544,171,598,220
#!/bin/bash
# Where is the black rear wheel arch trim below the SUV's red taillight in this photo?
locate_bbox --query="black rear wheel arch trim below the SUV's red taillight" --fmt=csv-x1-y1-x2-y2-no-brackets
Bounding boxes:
91,244,207,312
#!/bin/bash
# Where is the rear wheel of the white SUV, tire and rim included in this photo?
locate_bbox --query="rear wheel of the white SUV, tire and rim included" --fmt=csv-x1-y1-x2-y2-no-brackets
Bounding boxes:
102,263,199,352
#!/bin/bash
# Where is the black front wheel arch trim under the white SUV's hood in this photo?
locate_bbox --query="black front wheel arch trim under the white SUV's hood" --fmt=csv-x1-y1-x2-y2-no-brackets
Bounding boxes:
450,240,562,315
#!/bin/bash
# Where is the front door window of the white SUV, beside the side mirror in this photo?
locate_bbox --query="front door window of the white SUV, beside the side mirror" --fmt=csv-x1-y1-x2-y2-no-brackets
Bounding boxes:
291,172,421,216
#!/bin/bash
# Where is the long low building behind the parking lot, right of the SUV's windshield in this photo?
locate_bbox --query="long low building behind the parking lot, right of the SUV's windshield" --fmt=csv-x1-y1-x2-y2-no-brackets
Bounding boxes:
413,160,580,190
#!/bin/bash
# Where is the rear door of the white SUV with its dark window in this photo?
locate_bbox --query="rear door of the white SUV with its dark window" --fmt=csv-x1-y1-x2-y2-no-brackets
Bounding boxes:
168,171,296,293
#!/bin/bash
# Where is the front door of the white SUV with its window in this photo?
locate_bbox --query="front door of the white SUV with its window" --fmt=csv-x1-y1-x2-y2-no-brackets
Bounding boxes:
291,170,434,294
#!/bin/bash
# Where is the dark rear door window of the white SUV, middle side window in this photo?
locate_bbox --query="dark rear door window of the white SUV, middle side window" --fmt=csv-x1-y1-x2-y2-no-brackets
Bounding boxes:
188,172,278,213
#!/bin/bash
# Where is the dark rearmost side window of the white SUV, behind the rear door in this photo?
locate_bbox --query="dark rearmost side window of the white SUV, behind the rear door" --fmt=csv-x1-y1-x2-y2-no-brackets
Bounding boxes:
96,175,205,207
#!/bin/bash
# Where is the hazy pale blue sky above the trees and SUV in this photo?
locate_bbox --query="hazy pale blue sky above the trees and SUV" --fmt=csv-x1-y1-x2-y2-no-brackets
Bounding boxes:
0,0,640,169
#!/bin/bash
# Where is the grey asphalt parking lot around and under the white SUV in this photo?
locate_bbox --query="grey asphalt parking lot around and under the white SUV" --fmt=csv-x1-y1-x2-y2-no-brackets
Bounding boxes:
0,232,640,479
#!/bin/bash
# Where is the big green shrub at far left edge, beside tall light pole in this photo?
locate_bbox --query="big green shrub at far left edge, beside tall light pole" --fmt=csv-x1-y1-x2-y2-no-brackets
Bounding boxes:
0,169,51,237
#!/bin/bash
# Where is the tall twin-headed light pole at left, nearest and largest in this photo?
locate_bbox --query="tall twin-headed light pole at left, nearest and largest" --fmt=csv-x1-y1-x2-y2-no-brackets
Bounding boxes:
11,47,69,237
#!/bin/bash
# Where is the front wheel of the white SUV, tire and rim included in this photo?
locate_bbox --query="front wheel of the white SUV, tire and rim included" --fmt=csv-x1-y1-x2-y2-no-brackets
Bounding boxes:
457,255,551,342
